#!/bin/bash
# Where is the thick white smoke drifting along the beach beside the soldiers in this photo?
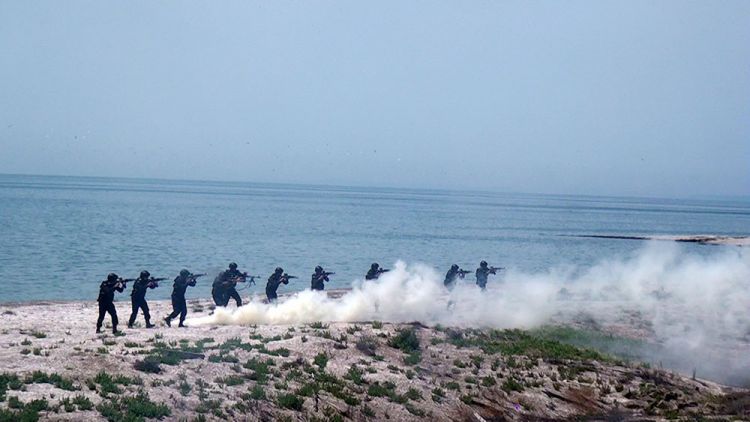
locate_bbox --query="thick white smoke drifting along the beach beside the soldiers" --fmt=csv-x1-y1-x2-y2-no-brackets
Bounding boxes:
189,242,750,383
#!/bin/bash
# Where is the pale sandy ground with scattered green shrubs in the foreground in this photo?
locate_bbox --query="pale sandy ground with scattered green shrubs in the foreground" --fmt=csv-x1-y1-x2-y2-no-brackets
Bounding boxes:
0,300,750,421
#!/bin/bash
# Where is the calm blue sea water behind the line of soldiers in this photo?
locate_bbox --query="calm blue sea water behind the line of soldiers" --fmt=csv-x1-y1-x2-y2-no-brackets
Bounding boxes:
0,175,750,302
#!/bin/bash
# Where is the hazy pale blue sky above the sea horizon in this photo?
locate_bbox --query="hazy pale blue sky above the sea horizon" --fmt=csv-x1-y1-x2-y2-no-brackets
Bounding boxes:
0,0,750,196
